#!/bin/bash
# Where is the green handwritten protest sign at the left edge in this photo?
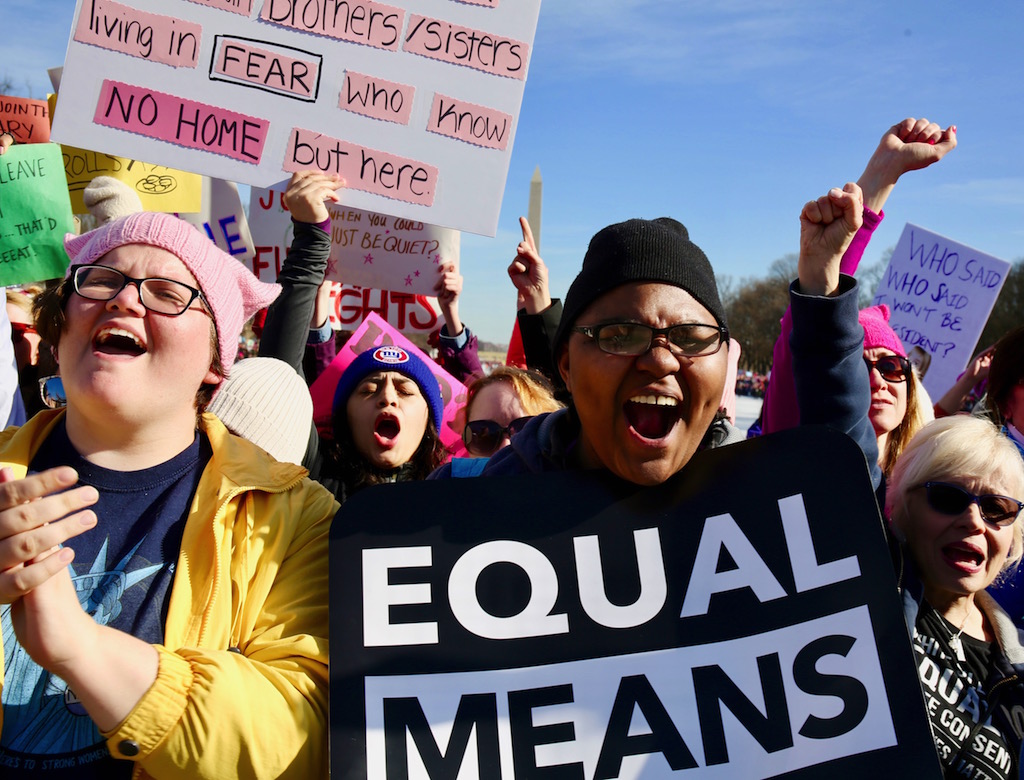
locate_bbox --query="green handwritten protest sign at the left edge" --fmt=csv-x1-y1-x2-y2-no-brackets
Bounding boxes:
0,143,75,286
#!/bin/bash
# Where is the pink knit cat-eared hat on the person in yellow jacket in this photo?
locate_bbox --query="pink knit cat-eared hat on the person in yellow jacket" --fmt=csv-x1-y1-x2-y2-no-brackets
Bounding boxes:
65,211,281,377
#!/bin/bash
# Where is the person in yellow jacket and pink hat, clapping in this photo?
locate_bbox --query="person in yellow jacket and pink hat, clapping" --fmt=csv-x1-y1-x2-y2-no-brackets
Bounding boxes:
0,212,338,780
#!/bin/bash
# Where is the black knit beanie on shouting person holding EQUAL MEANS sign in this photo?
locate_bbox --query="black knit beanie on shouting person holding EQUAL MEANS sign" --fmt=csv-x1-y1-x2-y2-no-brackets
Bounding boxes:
554,217,728,355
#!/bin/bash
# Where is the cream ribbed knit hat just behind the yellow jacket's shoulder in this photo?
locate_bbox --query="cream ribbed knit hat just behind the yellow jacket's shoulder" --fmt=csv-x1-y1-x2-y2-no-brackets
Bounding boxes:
209,357,313,465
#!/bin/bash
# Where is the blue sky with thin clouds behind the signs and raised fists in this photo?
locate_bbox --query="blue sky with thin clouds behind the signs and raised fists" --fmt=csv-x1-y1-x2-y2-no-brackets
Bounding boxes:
6,0,1024,343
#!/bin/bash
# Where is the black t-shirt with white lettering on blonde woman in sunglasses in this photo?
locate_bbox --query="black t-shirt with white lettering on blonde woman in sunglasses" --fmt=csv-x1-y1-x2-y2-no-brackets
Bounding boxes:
913,604,1024,780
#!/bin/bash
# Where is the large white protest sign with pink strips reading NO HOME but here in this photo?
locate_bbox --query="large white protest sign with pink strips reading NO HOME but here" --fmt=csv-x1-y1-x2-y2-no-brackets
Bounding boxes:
53,0,541,235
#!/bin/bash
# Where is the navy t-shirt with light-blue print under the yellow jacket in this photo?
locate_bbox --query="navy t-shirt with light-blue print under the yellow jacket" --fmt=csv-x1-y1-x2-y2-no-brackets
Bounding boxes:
0,424,211,780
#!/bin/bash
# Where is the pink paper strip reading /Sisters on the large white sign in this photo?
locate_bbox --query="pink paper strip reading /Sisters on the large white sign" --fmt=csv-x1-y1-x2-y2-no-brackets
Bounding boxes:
402,13,529,80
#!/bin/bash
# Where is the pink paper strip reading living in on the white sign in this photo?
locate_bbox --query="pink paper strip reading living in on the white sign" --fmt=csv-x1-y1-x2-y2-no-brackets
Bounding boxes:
75,0,203,68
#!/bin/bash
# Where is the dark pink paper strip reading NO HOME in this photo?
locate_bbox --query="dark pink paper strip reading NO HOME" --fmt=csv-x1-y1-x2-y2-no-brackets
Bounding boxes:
92,79,270,165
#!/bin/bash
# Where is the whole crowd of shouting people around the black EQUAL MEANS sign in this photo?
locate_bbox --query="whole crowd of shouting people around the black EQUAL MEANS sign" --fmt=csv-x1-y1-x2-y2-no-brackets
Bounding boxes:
0,111,1024,778
